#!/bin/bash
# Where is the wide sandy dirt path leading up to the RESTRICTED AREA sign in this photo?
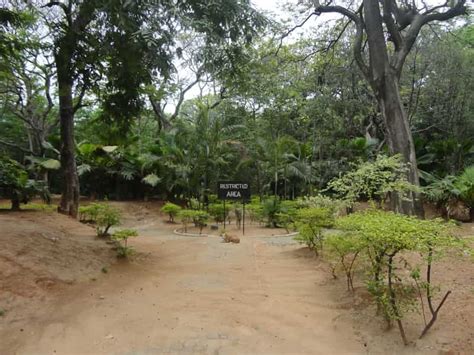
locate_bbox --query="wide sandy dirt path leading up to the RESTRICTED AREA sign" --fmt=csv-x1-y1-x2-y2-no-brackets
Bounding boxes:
0,232,364,354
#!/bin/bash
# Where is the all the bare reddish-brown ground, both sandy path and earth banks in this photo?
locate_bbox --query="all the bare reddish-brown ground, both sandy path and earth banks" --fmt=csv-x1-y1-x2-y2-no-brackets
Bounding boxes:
0,203,474,354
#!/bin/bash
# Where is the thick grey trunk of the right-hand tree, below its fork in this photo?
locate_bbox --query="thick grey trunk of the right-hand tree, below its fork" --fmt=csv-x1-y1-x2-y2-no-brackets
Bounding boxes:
377,69,424,217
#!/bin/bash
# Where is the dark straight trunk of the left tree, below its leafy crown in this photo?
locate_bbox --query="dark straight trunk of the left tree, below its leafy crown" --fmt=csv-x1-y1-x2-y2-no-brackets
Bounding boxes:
58,76,79,218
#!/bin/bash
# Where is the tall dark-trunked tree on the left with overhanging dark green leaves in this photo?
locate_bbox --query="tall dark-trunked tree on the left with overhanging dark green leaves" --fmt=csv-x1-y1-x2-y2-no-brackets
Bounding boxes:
29,0,262,216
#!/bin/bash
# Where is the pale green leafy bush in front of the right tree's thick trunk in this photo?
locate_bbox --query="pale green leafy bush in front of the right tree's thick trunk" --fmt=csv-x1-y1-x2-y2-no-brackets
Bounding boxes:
327,155,417,205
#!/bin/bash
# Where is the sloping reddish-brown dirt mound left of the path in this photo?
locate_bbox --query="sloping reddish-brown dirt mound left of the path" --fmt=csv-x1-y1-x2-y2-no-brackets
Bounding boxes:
0,211,114,318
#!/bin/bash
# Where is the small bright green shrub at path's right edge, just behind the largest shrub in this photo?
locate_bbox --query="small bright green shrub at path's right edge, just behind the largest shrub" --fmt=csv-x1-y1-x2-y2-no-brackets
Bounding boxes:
295,207,334,255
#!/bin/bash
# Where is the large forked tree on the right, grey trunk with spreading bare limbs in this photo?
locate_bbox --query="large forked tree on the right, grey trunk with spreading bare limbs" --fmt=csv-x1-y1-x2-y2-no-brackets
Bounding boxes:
313,0,466,217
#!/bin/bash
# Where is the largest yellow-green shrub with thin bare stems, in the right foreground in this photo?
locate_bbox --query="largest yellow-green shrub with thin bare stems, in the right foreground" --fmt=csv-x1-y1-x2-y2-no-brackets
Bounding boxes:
333,210,462,344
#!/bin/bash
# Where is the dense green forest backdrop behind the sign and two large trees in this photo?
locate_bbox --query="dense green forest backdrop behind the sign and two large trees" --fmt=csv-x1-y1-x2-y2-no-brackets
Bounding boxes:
0,1,474,214
